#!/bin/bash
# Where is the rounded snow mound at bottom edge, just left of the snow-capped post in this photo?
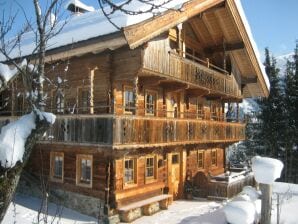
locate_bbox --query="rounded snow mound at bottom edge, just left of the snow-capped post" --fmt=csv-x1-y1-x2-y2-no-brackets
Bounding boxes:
223,201,255,224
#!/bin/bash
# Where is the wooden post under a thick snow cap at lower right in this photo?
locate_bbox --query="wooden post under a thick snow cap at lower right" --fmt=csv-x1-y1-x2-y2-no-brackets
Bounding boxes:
260,183,272,224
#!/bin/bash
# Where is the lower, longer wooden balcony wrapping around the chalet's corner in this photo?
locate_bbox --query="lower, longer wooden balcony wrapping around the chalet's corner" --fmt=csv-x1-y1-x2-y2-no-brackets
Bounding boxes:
39,114,245,149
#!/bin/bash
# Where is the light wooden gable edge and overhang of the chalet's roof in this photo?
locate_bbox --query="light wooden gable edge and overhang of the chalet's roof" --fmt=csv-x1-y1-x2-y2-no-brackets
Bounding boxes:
123,0,270,97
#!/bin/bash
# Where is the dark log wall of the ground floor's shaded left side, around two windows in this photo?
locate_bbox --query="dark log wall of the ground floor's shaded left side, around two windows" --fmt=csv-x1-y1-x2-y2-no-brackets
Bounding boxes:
26,144,107,200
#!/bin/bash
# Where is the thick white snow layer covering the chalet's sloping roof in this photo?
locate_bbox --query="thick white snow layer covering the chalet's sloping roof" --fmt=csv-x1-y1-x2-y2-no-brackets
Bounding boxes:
0,0,189,61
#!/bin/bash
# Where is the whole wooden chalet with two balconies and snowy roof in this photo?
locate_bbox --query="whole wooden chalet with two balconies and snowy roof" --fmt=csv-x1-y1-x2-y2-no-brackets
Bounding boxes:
0,0,269,223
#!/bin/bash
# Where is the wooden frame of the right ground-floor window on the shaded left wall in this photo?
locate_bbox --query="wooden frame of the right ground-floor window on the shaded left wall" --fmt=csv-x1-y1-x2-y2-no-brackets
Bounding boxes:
76,154,93,188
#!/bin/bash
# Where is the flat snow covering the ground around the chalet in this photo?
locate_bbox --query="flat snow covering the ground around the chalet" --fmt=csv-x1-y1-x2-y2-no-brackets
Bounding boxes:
2,182,298,224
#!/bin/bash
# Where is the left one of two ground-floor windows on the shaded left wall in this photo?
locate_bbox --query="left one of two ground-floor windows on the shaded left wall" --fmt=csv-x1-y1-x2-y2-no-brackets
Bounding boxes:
50,152,64,181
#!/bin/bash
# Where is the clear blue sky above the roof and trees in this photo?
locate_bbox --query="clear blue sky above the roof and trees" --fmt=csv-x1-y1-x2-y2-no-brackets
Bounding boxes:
0,0,298,56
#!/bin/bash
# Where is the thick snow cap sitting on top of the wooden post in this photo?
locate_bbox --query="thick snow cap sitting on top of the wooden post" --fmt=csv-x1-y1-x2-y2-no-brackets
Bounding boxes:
251,156,283,184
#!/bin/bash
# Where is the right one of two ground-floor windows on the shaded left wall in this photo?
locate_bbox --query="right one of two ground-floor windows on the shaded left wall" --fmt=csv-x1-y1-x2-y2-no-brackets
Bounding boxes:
77,155,92,187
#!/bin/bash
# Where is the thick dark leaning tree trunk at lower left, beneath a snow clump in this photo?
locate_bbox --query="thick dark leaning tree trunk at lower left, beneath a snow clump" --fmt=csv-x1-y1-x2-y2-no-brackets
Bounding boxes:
0,116,49,223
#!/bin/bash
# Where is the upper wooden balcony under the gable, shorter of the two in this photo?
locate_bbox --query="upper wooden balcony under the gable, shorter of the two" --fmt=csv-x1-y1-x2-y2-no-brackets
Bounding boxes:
143,49,242,99
